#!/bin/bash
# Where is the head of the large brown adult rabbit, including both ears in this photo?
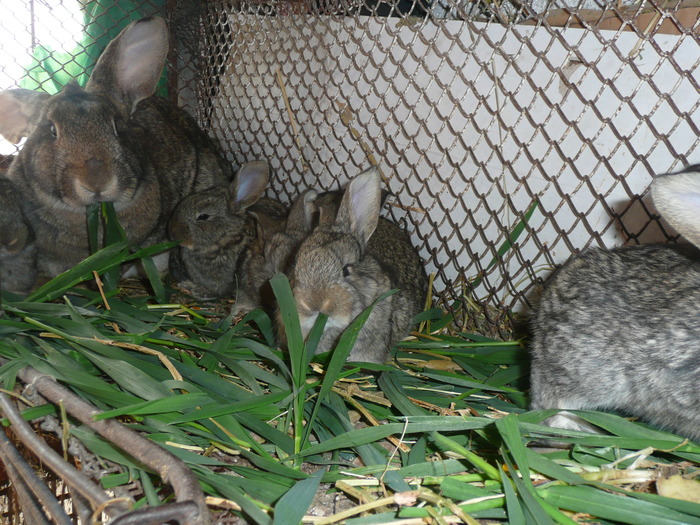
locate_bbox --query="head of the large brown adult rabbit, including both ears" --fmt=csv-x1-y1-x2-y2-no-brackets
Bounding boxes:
0,18,168,209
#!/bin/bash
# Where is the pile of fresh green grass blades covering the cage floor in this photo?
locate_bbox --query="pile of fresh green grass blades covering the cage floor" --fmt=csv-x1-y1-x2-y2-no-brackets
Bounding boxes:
0,204,700,525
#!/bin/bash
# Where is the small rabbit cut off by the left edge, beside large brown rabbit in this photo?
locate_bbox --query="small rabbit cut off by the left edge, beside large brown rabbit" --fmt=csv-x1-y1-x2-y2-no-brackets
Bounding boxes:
0,178,36,294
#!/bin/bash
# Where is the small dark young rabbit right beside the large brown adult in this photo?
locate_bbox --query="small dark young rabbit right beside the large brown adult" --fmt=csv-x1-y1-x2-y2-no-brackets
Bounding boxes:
168,161,287,299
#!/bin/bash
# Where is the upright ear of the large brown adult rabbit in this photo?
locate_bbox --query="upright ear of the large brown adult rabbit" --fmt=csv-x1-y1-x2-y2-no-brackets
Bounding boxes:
85,16,169,113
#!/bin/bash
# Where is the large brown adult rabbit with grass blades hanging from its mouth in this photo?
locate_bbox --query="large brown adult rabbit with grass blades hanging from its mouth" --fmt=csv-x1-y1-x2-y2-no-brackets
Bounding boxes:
0,17,230,277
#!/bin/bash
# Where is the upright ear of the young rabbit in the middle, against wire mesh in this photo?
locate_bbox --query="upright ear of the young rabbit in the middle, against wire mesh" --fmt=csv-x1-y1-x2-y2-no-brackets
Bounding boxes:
335,168,382,246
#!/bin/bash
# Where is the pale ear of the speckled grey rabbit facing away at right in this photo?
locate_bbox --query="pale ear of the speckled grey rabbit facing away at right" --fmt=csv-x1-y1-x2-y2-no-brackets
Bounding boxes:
651,165,700,247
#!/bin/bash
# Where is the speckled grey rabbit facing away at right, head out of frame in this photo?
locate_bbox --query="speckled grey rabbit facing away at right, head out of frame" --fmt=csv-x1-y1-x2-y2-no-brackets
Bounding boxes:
531,166,700,441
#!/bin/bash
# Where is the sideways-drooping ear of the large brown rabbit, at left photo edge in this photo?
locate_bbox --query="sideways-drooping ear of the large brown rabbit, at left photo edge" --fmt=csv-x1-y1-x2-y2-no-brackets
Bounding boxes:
0,89,51,144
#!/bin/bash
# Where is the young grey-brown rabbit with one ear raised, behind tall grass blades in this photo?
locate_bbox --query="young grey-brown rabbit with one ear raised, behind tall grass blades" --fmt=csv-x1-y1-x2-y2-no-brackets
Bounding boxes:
292,168,427,363
